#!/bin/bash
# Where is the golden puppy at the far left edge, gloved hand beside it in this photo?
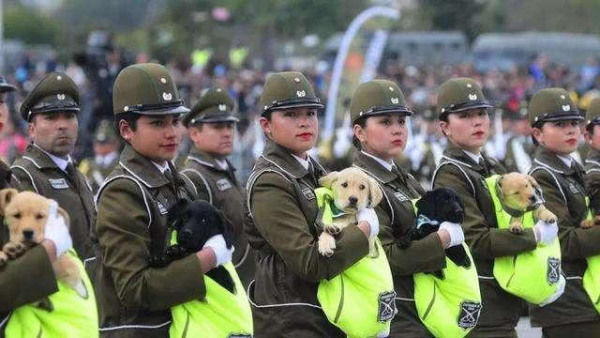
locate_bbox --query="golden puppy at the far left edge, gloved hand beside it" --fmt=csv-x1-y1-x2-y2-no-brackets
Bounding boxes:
0,189,87,297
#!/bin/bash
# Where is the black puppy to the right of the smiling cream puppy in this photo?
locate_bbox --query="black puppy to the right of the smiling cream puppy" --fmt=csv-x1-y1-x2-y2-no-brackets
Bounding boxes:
398,188,471,279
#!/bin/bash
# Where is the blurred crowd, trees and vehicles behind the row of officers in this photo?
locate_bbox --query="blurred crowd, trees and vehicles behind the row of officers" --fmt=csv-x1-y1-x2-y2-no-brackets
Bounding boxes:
0,0,600,186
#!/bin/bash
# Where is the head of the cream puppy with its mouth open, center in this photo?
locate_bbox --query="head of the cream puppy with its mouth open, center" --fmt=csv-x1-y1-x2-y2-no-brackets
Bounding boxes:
319,168,383,213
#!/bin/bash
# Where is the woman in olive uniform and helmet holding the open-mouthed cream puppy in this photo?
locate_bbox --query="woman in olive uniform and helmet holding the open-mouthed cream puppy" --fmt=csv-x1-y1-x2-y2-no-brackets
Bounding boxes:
245,72,379,337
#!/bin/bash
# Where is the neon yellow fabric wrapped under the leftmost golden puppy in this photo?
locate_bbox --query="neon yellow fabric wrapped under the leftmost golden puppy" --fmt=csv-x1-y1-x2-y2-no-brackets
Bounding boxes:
4,249,99,338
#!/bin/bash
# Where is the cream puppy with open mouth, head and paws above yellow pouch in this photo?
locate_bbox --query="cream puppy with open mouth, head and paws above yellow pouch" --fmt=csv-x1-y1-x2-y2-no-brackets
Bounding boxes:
318,168,383,257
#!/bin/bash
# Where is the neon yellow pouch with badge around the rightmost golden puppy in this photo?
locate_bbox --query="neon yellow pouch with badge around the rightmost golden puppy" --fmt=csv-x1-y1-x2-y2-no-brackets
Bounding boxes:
485,175,561,305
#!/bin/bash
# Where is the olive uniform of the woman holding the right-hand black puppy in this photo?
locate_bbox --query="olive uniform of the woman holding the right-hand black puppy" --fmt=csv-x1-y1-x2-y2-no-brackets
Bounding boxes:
354,152,446,338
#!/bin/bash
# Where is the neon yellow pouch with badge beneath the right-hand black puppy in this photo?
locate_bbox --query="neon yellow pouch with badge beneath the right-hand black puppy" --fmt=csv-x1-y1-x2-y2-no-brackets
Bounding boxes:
413,200,482,338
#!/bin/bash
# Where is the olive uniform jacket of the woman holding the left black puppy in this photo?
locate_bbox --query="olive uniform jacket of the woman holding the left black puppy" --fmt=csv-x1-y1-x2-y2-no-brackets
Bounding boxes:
96,146,205,337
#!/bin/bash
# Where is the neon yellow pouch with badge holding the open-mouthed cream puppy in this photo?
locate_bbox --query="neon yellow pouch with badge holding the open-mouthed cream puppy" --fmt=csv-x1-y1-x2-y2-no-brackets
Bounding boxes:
315,188,397,337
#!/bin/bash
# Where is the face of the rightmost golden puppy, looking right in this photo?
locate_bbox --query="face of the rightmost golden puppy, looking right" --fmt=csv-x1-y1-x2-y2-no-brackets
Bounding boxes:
498,172,541,211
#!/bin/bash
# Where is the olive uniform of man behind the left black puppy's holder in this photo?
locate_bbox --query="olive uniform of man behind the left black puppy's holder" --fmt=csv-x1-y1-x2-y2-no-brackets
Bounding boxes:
181,150,254,286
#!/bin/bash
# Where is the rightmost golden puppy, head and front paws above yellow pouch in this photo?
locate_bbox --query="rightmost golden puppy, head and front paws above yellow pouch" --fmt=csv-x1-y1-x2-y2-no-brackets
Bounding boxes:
497,172,557,233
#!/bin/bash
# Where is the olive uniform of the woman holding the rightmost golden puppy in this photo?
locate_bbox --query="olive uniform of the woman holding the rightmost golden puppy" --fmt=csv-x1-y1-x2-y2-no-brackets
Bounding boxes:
433,144,537,337
